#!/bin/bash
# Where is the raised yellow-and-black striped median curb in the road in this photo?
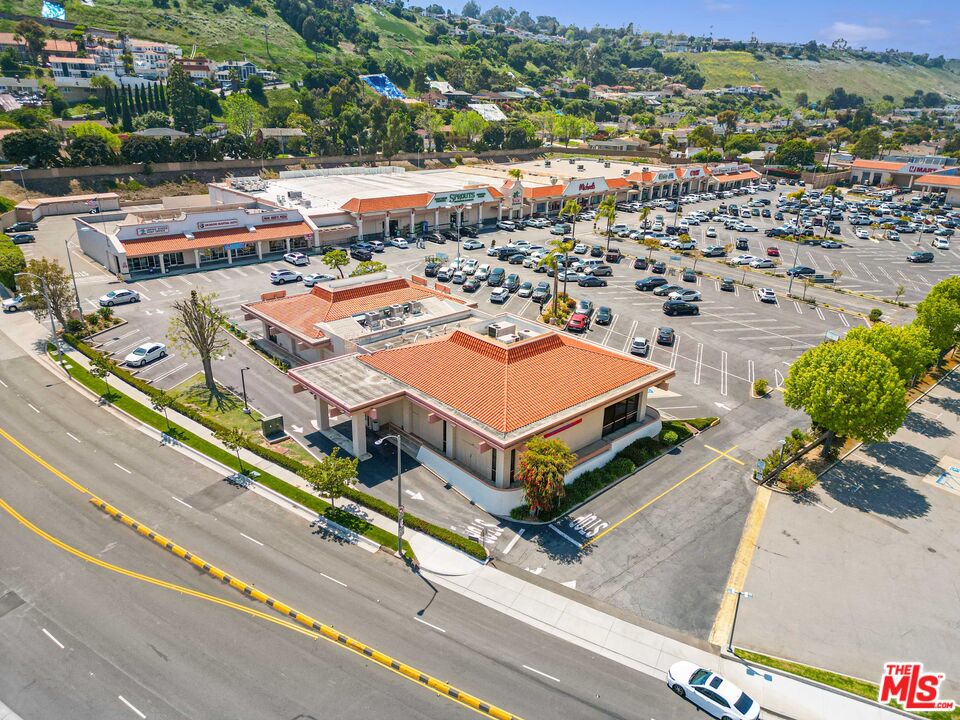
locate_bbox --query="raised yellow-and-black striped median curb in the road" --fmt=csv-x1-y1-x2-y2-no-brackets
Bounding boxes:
89,497,521,720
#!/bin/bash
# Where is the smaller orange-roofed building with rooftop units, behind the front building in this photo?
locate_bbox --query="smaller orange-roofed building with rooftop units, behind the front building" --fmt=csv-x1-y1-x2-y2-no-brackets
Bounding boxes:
240,272,477,365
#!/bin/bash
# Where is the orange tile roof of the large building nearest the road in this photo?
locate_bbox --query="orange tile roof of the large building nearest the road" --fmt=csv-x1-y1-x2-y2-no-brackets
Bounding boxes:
359,330,657,433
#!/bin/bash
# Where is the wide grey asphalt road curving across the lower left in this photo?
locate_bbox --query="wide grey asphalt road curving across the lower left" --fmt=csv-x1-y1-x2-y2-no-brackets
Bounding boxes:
0,328,694,720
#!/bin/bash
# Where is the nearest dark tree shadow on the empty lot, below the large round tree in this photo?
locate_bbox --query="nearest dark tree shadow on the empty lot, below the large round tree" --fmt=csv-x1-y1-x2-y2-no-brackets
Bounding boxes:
808,460,930,519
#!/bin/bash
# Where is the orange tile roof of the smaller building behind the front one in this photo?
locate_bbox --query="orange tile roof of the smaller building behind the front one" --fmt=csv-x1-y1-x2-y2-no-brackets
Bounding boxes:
243,278,462,339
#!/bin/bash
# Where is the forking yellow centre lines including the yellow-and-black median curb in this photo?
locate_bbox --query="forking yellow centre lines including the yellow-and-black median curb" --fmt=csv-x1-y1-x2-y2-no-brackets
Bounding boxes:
0,428,522,720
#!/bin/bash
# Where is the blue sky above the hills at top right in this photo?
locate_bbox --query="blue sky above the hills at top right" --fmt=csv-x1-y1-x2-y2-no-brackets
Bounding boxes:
474,0,960,58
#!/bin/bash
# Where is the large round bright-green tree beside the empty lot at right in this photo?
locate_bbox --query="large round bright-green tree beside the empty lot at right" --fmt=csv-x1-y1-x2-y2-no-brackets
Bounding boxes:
784,339,907,455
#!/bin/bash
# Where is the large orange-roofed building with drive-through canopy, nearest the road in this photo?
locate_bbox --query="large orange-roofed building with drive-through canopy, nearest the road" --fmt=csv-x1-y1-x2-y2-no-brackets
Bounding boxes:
289,315,675,515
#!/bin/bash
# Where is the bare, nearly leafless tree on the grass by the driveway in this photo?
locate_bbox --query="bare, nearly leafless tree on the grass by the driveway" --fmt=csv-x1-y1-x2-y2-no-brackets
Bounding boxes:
167,290,231,392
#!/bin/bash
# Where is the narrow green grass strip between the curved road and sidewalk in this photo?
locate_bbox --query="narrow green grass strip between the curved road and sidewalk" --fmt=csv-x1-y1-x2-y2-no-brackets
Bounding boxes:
50,352,415,559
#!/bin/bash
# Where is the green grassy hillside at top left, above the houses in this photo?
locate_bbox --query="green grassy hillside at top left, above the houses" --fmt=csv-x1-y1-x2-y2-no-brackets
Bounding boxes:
0,0,313,75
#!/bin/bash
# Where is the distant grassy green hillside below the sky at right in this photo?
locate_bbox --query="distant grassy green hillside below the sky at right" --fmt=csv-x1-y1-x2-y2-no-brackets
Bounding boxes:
684,51,960,101
